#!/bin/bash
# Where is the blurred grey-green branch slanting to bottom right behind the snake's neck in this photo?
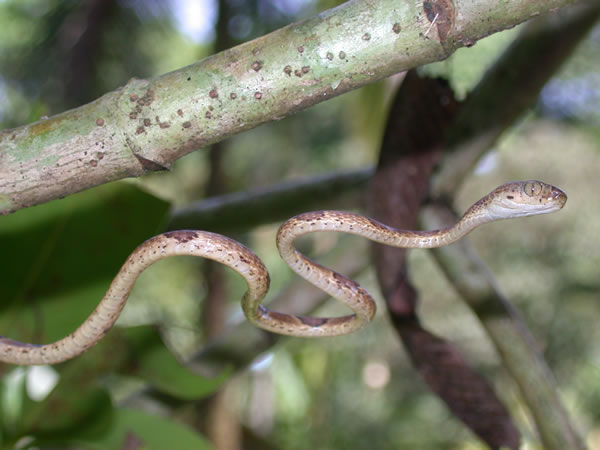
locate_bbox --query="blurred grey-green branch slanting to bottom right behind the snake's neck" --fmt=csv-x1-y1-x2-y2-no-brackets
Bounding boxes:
421,204,586,449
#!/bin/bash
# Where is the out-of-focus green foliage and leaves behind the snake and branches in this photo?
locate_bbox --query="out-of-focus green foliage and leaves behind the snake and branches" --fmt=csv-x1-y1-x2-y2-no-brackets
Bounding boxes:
0,0,600,449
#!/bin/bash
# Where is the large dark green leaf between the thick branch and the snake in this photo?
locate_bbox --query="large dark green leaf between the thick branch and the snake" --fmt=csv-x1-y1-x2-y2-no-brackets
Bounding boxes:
0,183,168,343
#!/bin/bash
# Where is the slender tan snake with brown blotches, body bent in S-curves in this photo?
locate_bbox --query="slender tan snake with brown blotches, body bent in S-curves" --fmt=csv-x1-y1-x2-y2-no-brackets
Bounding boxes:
0,180,567,365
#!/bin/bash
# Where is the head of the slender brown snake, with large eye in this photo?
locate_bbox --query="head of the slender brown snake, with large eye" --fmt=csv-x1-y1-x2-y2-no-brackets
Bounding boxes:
484,180,567,219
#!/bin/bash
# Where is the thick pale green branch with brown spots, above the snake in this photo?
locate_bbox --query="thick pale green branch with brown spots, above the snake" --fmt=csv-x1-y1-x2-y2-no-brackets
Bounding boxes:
0,0,571,214
